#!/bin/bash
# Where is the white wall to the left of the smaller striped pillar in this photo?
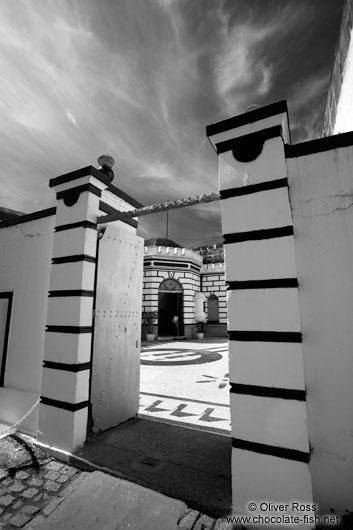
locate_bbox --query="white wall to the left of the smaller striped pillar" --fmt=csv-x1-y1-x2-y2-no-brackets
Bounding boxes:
0,212,55,430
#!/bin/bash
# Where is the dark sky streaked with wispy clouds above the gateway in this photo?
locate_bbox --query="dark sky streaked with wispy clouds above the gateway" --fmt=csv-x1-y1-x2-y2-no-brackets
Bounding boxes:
0,0,343,247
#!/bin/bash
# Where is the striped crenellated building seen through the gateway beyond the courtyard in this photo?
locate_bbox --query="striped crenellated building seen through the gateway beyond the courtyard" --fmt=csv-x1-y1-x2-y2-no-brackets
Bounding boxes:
142,238,227,338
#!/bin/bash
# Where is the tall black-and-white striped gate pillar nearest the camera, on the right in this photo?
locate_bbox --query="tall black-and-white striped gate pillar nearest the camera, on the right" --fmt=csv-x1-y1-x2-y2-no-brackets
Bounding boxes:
207,101,312,516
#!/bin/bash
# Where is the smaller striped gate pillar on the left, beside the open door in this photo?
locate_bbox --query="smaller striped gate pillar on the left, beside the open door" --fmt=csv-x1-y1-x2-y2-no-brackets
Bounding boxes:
38,166,109,451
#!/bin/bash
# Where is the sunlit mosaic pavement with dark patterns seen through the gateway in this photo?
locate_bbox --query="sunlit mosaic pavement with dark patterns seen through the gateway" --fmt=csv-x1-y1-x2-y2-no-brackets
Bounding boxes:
139,339,230,434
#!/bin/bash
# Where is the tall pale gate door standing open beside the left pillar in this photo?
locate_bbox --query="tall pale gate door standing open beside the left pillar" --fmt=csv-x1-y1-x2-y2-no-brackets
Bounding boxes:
91,223,143,432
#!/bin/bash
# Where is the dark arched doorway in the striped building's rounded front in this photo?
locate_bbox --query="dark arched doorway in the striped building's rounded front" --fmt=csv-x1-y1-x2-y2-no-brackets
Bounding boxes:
158,278,184,337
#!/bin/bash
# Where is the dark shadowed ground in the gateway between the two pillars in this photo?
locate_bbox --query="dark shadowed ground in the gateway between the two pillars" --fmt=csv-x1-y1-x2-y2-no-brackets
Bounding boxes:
70,418,231,518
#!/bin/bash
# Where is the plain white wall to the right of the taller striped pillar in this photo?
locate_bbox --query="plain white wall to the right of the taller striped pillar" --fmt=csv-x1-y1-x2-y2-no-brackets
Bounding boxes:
287,147,353,513
